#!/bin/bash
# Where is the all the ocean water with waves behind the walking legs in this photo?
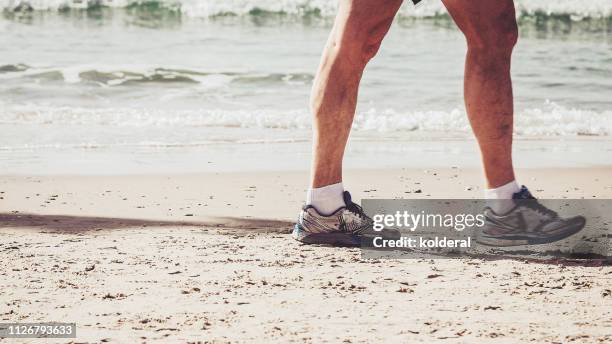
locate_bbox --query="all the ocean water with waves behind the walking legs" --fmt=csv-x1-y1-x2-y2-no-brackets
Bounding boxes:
0,0,612,173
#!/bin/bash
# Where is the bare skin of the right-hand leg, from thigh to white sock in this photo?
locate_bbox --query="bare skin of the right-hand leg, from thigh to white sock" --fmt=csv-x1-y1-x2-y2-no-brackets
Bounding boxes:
442,0,518,188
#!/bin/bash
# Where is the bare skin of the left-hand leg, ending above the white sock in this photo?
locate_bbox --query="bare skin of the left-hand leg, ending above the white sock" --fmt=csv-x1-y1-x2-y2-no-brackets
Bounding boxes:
311,0,402,188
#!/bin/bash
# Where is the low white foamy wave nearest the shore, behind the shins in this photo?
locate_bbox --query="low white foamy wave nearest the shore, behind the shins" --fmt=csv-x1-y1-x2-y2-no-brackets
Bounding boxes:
0,102,612,137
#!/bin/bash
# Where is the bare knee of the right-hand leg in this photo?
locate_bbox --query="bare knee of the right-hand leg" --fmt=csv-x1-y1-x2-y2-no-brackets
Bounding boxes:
466,15,518,57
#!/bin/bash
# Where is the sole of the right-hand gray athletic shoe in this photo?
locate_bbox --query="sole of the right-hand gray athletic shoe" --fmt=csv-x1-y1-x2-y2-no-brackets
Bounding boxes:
476,216,586,247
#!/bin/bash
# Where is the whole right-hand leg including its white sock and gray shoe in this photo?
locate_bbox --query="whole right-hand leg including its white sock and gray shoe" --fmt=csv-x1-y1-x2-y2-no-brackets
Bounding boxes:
442,0,586,246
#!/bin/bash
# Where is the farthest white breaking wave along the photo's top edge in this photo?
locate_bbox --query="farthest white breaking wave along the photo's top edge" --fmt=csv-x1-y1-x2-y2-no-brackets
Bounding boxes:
0,0,612,21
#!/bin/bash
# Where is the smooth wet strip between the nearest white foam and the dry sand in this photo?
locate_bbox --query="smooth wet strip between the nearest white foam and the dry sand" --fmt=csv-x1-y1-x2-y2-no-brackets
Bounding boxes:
1,133,612,176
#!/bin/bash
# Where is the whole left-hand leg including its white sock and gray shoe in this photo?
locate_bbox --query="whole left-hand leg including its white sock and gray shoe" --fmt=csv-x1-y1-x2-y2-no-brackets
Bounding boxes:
292,0,402,242
